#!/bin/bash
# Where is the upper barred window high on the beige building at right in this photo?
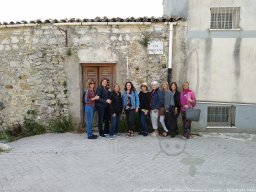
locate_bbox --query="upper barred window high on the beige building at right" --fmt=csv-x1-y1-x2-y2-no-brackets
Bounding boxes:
210,7,240,29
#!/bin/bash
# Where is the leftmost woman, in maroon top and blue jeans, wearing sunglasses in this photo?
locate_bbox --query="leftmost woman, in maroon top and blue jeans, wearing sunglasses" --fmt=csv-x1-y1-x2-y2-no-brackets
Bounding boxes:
84,80,99,139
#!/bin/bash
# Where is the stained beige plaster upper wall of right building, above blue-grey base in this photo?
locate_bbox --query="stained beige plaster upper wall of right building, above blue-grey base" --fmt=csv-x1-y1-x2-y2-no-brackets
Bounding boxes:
170,0,256,103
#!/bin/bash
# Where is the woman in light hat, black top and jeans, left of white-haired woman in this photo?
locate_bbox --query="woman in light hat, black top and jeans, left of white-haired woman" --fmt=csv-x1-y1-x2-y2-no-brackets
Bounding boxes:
139,83,150,136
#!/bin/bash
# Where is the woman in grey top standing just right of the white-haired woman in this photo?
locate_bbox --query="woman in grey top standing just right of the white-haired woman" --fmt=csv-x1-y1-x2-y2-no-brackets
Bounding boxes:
162,81,174,136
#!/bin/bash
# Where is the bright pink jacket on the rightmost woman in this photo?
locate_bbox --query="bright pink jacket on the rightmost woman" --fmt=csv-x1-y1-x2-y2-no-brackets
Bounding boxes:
180,89,196,112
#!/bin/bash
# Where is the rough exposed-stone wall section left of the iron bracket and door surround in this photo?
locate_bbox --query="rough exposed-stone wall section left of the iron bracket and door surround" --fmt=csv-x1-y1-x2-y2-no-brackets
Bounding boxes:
0,26,68,129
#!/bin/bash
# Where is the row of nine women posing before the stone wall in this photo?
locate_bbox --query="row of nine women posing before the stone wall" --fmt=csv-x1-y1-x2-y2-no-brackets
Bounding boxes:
83,78,196,139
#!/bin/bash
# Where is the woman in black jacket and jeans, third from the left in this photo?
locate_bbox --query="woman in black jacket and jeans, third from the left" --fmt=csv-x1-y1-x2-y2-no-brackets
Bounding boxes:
109,84,122,139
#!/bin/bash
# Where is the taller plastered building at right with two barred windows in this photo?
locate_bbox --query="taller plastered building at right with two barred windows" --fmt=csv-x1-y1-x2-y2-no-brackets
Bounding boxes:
163,0,256,132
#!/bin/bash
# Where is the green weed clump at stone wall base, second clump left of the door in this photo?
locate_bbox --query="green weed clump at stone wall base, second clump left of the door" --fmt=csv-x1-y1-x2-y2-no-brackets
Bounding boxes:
22,118,46,136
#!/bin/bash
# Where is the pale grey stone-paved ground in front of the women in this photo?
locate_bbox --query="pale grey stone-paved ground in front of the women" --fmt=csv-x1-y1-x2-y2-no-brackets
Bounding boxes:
0,133,256,192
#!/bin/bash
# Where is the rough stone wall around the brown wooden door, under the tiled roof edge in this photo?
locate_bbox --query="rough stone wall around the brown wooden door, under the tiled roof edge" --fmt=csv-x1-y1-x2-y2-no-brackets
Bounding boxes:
0,23,173,130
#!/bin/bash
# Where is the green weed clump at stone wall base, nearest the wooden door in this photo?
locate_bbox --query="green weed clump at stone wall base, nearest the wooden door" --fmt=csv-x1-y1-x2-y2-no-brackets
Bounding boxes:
49,117,74,133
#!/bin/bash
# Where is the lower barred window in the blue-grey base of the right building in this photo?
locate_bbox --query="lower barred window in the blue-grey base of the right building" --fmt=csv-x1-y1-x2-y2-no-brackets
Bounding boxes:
207,105,236,127
